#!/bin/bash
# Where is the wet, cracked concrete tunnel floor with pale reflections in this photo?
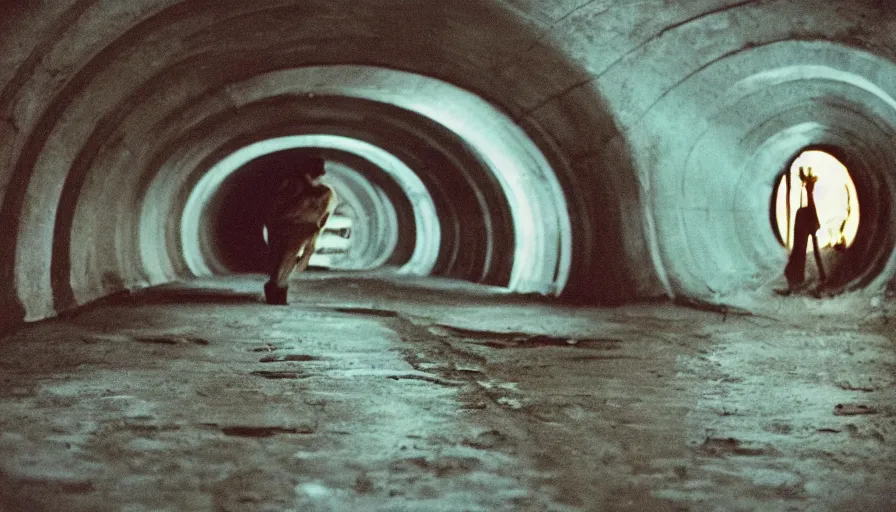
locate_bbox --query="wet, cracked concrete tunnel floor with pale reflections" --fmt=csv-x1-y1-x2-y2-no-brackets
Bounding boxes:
0,273,896,511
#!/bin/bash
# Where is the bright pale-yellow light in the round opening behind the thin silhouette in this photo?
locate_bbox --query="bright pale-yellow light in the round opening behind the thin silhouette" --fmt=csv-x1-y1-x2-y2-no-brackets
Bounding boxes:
775,150,859,252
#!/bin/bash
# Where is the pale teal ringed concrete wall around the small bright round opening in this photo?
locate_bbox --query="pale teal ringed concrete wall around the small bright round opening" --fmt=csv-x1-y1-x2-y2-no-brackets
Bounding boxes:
628,41,896,301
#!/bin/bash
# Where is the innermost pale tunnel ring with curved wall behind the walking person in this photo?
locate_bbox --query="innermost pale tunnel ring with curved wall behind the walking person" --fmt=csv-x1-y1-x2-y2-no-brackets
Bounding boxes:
185,135,430,279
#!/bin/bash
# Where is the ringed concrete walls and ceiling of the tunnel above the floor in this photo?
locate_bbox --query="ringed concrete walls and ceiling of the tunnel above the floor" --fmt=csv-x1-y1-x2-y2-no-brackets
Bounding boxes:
0,0,896,323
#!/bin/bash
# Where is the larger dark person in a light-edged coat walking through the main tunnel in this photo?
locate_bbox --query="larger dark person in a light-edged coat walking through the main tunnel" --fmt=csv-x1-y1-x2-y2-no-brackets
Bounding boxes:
264,157,336,305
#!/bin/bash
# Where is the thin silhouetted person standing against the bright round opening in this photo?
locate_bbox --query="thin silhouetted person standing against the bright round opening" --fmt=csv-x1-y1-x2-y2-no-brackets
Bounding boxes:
784,167,826,291
